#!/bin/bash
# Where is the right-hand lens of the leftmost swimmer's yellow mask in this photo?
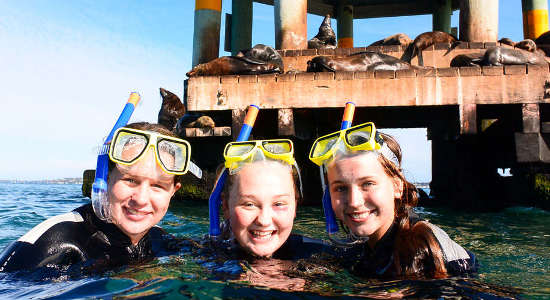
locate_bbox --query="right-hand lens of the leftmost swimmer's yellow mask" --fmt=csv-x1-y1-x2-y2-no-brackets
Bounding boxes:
157,139,188,172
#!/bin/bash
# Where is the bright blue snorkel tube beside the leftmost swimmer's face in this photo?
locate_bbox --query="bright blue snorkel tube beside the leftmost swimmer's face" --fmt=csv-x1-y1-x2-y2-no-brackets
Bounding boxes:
91,92,141,221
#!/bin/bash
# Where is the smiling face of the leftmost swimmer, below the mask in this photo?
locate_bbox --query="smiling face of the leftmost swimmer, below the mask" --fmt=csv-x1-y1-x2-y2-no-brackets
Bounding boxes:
109,148,181,244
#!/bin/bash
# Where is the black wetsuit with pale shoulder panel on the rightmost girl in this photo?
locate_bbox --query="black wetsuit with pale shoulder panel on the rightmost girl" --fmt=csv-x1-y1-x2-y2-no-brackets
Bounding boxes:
353,217,479,277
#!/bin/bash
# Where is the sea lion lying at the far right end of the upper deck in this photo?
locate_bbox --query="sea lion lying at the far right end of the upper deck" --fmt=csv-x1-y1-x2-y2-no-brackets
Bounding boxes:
451,47,548,67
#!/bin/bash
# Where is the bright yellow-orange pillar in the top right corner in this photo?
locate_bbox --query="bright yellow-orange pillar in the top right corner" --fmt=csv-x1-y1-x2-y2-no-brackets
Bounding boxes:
521,0,548,40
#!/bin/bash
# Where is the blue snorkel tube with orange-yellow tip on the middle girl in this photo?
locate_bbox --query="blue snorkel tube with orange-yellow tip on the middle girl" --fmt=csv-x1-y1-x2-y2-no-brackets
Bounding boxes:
208,104,260,239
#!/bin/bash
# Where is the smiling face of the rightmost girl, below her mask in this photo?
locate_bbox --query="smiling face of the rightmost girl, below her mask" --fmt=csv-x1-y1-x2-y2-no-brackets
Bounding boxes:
327,152,402,245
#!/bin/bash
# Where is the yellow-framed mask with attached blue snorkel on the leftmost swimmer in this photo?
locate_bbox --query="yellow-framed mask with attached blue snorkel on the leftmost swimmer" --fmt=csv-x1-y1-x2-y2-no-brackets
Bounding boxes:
92,93,202,222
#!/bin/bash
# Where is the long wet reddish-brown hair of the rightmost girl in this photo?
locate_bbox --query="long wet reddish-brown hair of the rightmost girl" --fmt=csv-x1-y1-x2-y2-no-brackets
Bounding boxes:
370,133,447,278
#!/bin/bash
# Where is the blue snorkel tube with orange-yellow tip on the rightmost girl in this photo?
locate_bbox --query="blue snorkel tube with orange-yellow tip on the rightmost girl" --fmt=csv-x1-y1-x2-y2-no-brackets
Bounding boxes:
319,102,355,238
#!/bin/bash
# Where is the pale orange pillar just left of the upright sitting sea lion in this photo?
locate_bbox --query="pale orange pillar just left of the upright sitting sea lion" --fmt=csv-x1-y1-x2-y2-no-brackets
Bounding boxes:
274,0,307,49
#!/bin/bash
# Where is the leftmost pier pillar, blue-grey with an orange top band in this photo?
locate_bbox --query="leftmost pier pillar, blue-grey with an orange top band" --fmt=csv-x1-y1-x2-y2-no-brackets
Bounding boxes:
193,0,222,66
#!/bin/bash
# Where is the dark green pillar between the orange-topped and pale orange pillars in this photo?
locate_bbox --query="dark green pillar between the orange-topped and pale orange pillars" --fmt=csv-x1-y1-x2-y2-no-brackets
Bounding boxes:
231,0,252,55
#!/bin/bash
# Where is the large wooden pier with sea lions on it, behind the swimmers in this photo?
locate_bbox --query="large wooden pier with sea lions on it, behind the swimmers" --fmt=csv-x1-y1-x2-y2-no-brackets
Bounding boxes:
185,0,550,210
